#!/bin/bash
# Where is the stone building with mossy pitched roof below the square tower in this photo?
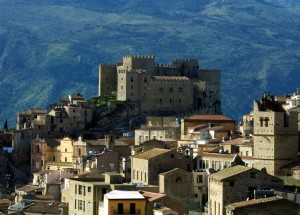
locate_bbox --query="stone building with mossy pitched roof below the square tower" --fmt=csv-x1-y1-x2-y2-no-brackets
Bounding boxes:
208,165,283,215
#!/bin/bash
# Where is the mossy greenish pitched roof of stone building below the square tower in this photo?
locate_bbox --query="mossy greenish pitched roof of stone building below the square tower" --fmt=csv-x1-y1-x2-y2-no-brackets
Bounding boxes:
209,165,252,181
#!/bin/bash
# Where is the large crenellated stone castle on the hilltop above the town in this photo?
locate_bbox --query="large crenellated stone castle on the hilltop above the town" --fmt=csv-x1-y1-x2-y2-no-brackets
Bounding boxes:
99,55,222,114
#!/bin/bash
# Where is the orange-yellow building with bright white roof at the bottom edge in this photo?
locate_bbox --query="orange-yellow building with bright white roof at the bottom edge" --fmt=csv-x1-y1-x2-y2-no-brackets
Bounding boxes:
99,190,146,215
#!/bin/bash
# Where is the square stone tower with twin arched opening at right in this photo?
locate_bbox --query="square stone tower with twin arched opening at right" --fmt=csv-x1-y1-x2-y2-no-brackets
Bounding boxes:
253,93,298,176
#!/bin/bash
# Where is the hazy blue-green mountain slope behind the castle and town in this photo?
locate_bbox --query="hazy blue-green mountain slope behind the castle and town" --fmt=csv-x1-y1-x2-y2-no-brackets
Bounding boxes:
0,0,300,127
